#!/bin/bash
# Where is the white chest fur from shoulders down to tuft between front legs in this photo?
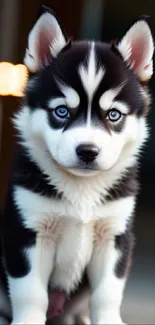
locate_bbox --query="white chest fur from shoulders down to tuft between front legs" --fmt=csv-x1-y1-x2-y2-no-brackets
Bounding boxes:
14,187,135,292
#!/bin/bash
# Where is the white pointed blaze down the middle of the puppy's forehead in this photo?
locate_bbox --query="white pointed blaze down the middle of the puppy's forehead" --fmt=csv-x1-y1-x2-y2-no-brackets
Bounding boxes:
79,42,105,101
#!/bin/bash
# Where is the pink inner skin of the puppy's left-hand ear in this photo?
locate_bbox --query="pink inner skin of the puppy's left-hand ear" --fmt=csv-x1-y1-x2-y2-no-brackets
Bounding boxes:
37,28,55,65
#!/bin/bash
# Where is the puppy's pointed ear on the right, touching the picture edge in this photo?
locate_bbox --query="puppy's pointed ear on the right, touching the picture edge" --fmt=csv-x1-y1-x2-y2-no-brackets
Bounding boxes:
117,17,154,82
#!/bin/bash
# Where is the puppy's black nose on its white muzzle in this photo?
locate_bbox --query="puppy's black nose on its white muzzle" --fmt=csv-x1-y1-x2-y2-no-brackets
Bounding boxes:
76,144,99,163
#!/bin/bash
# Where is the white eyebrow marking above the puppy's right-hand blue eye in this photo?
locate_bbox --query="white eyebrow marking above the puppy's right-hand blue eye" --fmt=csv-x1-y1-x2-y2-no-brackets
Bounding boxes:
99,82,126,111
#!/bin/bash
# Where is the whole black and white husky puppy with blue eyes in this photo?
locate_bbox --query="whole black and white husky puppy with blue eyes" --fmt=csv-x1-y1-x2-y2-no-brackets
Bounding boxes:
2,8,154,324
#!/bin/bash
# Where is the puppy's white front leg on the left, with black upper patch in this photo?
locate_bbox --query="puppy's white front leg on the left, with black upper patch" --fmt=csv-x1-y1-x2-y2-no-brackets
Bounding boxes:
6,236,55,325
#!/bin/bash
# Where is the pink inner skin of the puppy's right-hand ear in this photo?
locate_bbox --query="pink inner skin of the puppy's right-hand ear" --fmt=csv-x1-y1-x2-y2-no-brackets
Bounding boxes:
129,37,147,70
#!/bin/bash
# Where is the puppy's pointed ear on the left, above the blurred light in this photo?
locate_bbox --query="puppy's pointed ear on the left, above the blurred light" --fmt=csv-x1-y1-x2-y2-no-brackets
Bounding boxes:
24,6,67,72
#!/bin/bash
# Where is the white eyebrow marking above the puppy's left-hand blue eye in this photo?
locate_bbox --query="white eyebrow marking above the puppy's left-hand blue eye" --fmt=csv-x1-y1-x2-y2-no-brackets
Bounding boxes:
56,79,80,108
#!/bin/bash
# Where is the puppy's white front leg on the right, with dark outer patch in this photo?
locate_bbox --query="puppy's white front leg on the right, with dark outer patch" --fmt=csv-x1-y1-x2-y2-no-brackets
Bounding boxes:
88,223,133,324
